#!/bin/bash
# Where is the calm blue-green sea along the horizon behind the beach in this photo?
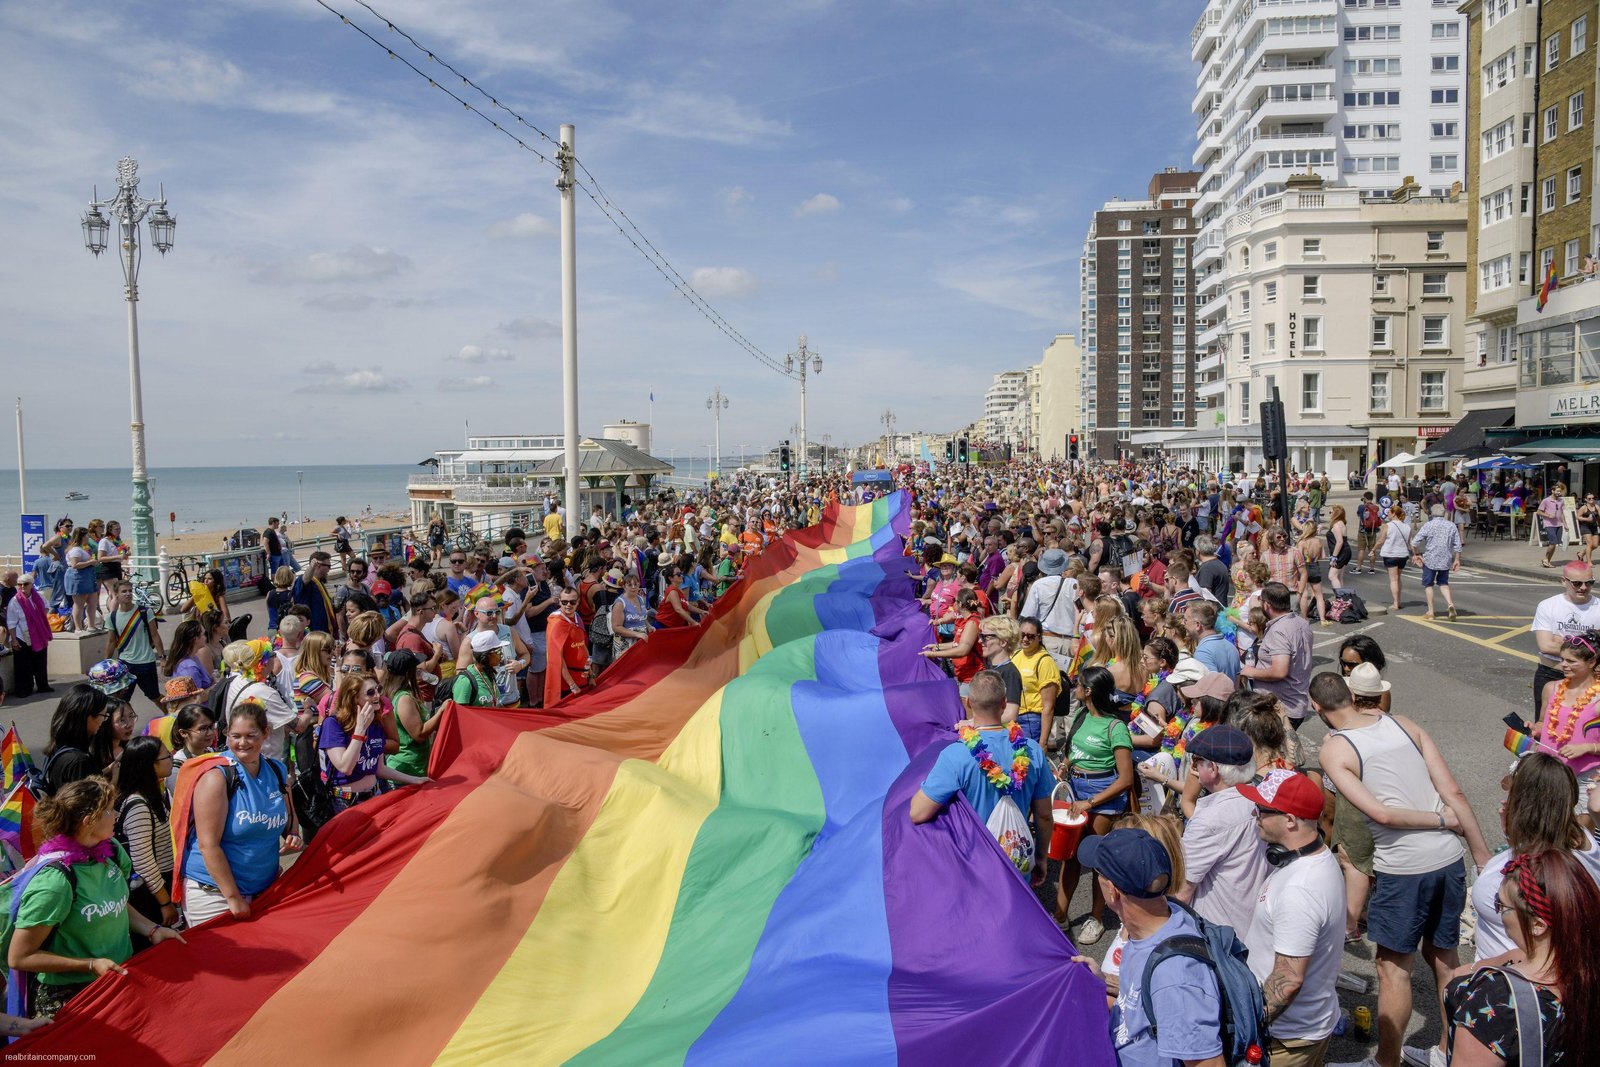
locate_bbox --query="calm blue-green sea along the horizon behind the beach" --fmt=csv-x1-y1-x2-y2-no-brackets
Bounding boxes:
0,454,754,553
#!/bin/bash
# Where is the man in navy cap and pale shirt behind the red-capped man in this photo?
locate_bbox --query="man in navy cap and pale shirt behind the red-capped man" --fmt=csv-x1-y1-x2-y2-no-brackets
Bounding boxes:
1173,723,1272,931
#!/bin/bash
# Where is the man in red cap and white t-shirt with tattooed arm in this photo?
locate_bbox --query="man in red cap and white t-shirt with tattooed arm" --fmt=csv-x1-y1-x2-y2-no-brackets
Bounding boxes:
1238,771,1344,1067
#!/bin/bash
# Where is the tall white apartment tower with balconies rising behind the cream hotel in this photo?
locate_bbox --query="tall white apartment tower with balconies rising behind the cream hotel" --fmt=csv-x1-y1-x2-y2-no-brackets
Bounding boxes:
1190,0,1467,422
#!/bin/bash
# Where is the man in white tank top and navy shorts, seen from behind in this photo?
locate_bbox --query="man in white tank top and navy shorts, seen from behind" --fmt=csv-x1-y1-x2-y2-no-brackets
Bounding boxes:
1310,672,1490,1067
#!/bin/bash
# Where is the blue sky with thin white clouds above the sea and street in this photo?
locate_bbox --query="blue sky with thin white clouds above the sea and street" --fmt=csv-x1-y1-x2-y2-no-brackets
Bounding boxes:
0,0,1203,466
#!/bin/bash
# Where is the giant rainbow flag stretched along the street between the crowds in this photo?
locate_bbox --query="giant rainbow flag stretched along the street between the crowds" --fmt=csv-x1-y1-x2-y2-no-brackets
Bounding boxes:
13,494,1115,1067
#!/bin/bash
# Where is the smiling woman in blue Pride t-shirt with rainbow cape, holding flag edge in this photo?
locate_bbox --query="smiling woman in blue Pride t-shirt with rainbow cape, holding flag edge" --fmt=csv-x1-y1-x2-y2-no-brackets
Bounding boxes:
184,701,301,926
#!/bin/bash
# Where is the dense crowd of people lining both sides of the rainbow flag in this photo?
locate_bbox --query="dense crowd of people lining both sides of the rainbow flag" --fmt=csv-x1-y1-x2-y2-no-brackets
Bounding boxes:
6,462,1600,1067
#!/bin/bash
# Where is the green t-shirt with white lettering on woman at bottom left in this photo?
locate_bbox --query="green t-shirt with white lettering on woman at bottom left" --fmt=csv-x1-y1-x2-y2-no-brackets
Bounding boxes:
16,841,133,985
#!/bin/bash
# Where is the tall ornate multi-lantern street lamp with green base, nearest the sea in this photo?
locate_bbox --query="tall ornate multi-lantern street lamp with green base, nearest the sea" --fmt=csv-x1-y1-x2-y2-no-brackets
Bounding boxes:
83,155,178,573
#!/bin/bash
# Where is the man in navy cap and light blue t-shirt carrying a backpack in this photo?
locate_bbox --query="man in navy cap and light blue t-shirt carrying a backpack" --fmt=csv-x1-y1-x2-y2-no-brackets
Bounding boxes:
1072,825,1222,1067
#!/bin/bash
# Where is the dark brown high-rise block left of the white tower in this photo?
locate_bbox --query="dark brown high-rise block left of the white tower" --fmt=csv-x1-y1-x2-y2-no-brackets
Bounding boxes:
1078,168,1198,459
